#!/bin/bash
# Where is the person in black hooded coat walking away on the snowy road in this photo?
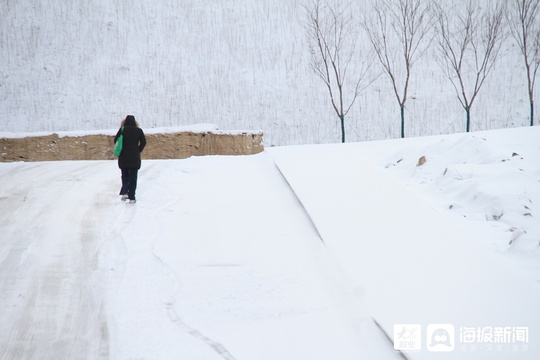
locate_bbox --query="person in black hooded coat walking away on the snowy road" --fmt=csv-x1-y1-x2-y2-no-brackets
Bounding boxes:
114,115,146,204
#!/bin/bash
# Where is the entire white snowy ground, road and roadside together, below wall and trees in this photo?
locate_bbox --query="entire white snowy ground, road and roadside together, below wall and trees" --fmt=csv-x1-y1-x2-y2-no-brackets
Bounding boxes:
0,127,540,360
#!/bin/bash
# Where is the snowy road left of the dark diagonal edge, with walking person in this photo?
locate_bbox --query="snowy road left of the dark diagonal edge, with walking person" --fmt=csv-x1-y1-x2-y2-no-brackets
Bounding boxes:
0,154,397,360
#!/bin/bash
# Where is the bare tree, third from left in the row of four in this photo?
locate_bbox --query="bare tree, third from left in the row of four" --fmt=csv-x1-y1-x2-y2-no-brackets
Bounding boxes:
436,0,505,132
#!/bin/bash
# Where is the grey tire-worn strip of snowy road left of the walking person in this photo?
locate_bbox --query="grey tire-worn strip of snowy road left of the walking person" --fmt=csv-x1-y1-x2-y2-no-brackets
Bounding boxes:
0,162,114,359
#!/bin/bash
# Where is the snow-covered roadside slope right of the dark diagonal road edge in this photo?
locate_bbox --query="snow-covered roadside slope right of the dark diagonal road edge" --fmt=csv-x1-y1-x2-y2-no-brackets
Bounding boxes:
270,128,540,359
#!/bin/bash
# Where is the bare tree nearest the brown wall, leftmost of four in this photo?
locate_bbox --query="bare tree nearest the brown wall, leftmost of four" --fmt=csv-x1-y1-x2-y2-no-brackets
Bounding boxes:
304,0,370,142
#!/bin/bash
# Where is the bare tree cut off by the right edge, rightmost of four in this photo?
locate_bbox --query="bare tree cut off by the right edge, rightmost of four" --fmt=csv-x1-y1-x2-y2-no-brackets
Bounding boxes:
508,0,540,126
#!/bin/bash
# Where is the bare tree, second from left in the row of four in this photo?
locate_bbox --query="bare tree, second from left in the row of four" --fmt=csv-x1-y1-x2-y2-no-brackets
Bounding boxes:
362,0,431,138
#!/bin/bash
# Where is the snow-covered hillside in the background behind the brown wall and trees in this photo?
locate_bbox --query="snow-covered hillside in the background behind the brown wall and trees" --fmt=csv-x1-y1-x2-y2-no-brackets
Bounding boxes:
0,0,538,146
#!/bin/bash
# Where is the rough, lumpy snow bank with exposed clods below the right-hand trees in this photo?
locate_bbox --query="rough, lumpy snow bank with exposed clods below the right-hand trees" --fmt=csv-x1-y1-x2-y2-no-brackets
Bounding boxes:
376,126,540,258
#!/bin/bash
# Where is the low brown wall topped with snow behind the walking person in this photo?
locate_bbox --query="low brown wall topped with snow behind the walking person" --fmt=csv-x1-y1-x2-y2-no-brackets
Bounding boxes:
0,132,264,162
